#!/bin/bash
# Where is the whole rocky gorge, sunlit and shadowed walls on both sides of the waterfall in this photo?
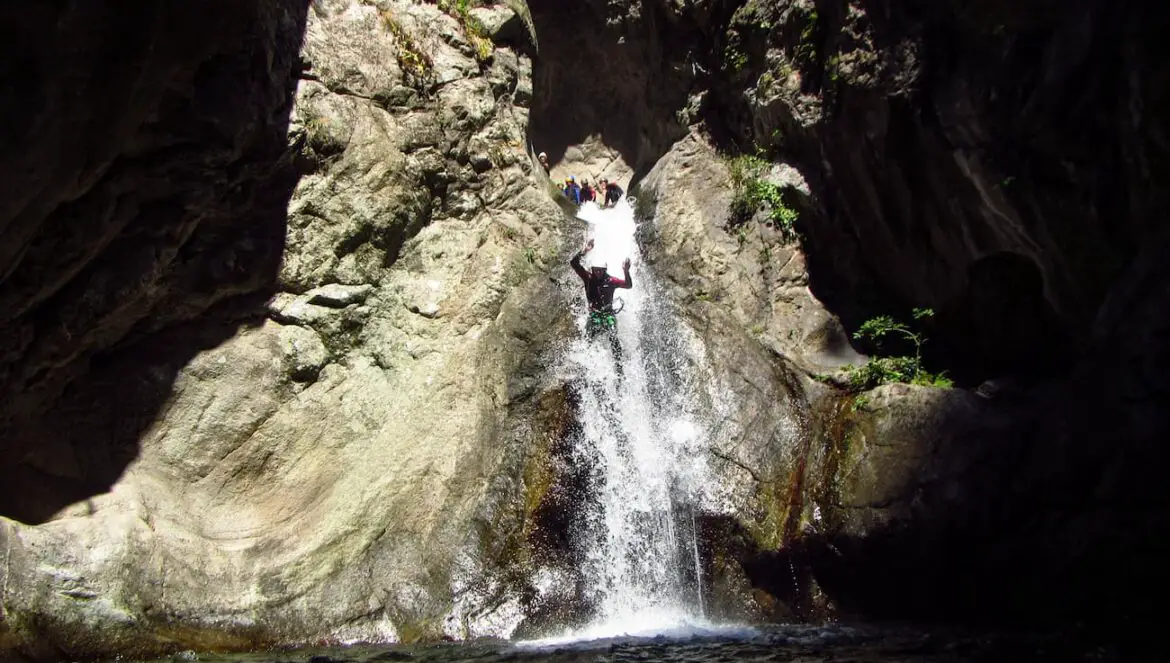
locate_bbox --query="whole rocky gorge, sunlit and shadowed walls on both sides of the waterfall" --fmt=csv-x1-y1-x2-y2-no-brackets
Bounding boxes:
0,0,1170,661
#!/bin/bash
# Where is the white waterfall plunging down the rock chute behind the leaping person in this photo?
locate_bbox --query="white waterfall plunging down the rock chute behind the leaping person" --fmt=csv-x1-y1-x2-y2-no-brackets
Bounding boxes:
554,201,709,638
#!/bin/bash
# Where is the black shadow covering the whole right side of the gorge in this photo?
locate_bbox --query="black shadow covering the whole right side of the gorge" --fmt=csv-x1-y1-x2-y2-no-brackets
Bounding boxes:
692,0,1170,637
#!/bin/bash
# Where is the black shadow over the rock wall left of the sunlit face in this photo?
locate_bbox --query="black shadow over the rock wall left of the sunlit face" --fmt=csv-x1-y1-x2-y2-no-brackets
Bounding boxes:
0,0,309,524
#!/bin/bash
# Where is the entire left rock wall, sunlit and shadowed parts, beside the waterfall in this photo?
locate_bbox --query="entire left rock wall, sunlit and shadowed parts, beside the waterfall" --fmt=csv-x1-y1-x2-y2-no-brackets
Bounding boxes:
0,0,565,658
